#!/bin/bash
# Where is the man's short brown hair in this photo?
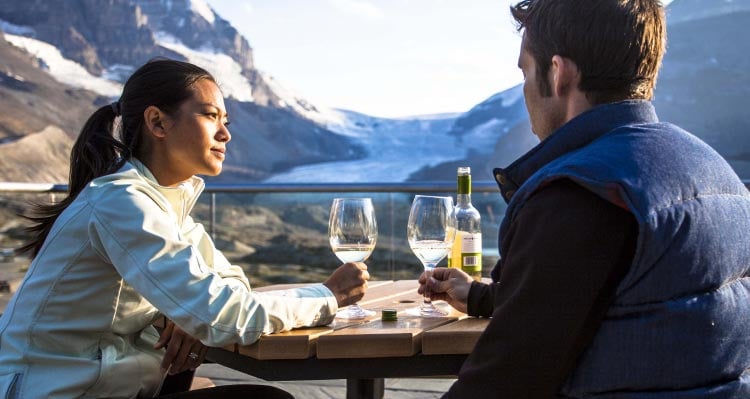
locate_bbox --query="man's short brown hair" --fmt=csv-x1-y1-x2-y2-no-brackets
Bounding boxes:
511,0,667,105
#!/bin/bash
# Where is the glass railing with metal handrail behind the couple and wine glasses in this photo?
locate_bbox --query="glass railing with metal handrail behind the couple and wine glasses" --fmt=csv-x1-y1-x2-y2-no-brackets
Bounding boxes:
0,182,750,286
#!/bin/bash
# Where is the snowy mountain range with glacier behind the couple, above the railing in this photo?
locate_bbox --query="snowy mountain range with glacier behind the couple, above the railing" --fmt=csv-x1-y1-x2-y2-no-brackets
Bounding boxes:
0,0,750,182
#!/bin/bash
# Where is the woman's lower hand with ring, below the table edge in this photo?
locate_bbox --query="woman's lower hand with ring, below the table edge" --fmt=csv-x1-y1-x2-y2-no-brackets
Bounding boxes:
154,320,208,374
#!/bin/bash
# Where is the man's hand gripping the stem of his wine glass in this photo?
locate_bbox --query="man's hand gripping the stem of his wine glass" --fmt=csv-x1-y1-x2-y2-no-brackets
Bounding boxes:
417,267,474,313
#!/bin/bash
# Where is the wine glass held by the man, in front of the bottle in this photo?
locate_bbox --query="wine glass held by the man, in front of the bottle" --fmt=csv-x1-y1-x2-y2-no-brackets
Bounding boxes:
406,195,456,317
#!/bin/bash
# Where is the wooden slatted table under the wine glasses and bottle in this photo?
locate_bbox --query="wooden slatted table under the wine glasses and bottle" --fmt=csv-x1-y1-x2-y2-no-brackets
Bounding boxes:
207,280,489,398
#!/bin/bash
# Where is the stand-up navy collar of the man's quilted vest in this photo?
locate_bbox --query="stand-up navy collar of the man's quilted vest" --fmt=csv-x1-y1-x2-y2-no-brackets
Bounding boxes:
493,100,659,202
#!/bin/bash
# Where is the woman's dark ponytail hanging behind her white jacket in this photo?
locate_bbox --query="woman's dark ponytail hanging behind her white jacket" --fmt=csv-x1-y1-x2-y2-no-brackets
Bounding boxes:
18,103,130,258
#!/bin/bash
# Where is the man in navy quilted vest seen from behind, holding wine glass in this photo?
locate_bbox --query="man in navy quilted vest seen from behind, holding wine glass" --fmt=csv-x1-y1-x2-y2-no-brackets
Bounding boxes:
420,0,750,399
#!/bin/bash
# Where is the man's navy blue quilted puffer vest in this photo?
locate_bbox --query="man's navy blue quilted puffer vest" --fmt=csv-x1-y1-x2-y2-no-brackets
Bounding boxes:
492,101,750,399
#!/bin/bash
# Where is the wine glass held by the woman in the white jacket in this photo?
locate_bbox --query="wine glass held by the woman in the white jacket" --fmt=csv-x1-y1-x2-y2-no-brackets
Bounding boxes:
328,198,378,319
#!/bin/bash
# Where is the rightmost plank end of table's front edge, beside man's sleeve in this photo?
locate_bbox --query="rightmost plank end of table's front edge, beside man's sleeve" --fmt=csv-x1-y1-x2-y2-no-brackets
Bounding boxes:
422,317,490,355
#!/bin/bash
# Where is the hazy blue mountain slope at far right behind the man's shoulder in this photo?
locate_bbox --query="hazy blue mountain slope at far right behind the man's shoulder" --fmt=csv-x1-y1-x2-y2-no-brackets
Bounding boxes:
654,8,750,179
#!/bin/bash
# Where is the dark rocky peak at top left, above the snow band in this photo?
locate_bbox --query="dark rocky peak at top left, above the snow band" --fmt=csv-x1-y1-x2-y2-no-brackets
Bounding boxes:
0,0,253,75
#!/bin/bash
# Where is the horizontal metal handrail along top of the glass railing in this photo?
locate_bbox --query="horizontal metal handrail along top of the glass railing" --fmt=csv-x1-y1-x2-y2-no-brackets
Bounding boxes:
0,180,750,194
